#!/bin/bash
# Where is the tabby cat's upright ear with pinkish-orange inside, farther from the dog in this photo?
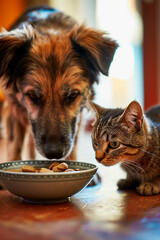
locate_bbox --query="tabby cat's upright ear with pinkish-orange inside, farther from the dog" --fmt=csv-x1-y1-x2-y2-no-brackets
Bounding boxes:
119,101,143,131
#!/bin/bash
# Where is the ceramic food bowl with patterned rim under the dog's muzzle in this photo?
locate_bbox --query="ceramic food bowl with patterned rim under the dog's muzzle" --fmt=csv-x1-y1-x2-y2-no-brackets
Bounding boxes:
0,160,98,203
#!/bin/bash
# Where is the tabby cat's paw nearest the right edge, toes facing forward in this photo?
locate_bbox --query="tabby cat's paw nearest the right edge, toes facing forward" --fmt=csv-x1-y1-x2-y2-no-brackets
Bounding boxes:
137,182,160,196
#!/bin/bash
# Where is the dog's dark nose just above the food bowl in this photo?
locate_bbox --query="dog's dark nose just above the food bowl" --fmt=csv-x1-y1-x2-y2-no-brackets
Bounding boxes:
43,144,63,159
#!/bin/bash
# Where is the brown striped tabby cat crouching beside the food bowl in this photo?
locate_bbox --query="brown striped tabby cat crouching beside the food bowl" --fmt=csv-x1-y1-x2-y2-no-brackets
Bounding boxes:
89,100,160,195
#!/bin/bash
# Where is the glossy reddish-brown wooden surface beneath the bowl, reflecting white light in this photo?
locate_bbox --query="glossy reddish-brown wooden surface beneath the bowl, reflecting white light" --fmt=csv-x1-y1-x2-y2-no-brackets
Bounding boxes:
0,167,160,240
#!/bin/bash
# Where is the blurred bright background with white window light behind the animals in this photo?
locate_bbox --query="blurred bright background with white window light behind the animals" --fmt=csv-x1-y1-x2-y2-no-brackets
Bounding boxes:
0,0,160,110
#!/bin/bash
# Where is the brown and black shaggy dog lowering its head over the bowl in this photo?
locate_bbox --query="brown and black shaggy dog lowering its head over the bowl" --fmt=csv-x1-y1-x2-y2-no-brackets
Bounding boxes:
0,7,117,160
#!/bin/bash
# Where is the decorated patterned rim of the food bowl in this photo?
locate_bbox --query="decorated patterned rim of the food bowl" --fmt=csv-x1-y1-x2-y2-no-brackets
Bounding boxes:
0,159,98,177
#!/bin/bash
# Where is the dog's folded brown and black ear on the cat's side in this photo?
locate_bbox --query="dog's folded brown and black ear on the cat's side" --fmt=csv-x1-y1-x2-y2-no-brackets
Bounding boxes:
71,25,118,75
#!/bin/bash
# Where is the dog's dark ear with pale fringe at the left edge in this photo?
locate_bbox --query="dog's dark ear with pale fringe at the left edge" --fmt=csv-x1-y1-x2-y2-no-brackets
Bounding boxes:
0,26,33,91
